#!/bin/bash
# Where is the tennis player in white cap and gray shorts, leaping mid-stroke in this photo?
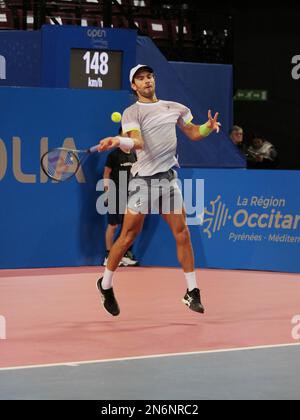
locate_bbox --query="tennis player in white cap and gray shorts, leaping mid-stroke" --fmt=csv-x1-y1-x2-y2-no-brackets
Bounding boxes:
97,64,220,316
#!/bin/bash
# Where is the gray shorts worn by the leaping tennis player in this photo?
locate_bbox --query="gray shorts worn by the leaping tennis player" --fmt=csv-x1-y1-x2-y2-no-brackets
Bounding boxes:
127,169,183,214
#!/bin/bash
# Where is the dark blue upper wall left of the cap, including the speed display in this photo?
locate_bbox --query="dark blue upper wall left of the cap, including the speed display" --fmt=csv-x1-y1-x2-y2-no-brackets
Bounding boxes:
0,25,136,90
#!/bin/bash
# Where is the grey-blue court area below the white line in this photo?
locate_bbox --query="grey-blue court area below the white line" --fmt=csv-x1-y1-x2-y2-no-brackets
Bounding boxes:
0,344,300,401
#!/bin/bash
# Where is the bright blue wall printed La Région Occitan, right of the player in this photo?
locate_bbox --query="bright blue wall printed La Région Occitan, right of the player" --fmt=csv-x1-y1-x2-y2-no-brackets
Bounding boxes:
136,169,300,273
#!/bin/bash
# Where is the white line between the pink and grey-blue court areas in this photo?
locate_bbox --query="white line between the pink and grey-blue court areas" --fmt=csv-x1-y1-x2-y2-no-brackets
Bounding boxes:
0,343,300,372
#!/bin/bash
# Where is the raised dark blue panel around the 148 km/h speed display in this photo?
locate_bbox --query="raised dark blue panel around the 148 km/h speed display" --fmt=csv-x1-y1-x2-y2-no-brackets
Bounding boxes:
42,25,136,90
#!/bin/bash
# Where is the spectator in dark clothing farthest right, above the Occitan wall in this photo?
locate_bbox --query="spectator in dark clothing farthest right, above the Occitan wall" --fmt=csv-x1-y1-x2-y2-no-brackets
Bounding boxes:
247,136,278,169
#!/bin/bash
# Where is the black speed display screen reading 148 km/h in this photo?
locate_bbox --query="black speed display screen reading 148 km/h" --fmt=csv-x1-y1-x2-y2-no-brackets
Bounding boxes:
70,48,123,90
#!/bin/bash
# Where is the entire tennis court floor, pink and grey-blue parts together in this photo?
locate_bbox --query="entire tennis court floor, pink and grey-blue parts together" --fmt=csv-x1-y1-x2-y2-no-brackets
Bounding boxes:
0,267,300,400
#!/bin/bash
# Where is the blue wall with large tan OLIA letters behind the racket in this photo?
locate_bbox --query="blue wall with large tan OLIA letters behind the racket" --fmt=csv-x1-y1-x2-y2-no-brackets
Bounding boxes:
0,88,128,268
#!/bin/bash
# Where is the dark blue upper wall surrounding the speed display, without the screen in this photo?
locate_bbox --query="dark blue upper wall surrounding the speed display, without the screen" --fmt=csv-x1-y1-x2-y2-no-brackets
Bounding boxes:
0,25,136,90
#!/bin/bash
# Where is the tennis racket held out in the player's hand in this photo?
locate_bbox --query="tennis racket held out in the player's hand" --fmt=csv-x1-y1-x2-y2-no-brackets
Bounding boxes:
41,144,99,181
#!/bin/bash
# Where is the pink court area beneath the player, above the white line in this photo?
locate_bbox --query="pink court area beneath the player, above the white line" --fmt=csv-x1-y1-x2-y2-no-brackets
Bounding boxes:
0,267,300,368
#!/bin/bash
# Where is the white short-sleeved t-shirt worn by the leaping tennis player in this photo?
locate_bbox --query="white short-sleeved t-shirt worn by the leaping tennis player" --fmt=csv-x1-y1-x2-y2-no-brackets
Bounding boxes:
122,101,193,176
